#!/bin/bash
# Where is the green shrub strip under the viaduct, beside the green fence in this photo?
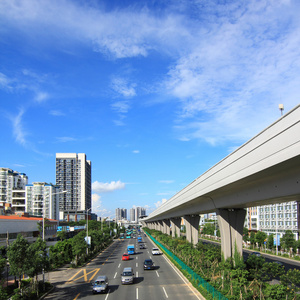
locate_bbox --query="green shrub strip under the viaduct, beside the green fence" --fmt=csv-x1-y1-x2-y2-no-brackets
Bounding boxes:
143,228,300,300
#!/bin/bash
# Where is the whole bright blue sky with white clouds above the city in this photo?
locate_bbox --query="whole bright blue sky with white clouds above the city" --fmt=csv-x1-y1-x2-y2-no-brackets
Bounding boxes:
0,0,300,217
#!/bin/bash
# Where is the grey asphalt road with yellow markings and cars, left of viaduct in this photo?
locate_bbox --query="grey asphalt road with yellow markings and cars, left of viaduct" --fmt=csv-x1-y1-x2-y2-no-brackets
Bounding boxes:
45,236,204,300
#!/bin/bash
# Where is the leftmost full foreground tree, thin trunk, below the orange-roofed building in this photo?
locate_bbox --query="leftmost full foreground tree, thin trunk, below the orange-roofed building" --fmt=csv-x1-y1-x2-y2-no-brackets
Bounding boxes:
7,234,29,289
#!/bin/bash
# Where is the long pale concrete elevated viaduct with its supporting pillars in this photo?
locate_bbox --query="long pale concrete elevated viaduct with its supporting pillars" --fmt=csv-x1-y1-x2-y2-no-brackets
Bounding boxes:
143,105,300,259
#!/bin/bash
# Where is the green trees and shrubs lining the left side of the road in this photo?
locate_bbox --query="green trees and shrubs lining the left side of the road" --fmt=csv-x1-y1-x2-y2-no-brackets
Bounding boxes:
0,221,117,300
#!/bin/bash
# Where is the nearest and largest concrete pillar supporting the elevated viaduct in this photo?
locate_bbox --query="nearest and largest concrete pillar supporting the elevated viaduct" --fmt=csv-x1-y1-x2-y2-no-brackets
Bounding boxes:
217,209,246,260
